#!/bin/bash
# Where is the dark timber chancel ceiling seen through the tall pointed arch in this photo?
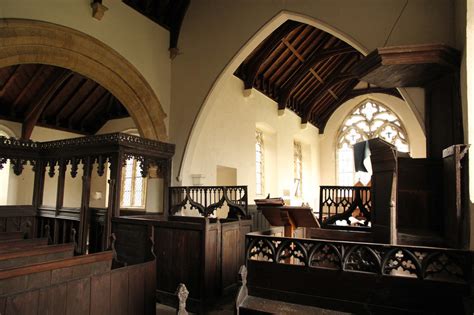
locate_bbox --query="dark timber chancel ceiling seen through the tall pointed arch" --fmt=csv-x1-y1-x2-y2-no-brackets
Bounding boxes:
234,20,401,133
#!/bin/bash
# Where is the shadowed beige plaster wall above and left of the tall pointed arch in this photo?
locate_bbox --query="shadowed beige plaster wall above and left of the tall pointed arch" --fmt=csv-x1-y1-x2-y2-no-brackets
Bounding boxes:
170,0,454,179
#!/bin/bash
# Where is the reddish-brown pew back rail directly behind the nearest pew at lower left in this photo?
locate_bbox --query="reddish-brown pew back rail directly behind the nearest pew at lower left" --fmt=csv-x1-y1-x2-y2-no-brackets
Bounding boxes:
0,251,113,280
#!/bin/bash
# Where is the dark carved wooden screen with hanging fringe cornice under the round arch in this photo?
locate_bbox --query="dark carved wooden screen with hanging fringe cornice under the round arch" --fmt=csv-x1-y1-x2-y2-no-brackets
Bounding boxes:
0,133,174,253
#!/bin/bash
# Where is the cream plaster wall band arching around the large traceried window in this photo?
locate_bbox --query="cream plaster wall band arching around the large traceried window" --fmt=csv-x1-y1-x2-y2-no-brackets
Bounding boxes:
320,93,426,185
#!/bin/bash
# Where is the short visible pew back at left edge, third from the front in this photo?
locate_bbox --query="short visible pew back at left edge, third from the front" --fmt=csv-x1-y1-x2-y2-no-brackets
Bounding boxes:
0,243,74,269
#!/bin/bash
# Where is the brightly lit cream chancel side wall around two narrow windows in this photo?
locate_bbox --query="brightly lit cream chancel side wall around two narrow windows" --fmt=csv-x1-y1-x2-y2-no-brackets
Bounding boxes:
183,76,319,210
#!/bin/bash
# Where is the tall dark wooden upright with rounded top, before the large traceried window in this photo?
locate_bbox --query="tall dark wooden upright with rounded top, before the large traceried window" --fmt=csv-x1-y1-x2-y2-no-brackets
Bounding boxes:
369,138,397,244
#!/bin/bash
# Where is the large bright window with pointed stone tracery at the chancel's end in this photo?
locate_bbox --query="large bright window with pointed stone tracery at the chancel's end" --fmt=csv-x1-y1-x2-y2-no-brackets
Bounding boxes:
336,99,409,186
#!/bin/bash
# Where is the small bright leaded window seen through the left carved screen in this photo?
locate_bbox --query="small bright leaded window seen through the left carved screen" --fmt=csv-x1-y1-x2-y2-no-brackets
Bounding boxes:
120,158,146,208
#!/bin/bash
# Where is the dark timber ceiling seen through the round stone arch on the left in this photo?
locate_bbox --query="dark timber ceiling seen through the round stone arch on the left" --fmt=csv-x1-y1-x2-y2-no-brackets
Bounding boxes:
0,64,129,139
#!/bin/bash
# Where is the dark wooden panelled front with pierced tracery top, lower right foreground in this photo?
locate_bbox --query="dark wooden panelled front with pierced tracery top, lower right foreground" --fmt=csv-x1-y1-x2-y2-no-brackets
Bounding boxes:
246,233,473,314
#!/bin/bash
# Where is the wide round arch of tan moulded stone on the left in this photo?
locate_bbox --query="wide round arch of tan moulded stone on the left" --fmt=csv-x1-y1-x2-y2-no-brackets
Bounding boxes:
0,19,168,141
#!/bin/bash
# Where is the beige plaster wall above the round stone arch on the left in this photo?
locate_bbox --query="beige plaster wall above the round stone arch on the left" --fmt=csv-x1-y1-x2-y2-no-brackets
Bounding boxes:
0,0,171,133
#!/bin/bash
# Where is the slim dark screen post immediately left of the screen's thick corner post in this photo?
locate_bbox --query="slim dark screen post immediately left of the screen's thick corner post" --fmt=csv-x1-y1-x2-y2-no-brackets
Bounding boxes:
78,156,94,254
